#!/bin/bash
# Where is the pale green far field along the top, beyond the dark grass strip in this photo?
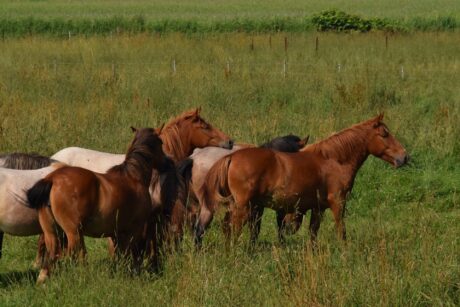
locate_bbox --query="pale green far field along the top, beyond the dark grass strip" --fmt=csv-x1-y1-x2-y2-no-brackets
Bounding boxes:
0,0,460,20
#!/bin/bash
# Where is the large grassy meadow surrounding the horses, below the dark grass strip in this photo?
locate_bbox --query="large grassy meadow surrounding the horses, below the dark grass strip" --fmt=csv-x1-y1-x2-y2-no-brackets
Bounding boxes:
0,32,460,306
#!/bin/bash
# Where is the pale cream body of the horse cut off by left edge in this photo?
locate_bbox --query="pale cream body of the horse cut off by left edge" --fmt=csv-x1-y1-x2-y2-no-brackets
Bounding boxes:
0,164,62,236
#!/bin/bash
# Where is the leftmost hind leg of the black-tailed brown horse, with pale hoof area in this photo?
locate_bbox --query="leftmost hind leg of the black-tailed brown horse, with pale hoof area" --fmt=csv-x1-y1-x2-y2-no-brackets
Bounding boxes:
37,208,59,284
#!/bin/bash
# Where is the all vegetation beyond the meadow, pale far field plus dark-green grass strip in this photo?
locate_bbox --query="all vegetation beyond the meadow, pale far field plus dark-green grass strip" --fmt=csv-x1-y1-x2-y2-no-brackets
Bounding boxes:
0,0,460,37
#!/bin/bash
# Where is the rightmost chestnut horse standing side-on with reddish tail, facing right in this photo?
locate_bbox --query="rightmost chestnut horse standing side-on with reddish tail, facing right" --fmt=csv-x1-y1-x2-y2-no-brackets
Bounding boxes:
195,115,409,246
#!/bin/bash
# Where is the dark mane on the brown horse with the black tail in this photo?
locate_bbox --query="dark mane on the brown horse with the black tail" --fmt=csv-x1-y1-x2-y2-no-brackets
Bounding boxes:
107,128,163,186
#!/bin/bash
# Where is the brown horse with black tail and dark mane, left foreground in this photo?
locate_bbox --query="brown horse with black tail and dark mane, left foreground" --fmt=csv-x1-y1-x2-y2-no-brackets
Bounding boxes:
27,128,166,282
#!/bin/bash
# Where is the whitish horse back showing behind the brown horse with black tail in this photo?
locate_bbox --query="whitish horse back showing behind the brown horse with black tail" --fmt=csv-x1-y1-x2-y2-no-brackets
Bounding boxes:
51,147,125,173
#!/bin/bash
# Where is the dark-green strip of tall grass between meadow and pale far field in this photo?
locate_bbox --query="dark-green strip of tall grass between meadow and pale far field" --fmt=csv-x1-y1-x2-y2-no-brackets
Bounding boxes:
0,15,460,39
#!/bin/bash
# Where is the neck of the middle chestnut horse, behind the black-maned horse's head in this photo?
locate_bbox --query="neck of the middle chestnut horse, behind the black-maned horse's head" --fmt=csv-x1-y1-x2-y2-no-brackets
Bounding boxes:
160,123,195,162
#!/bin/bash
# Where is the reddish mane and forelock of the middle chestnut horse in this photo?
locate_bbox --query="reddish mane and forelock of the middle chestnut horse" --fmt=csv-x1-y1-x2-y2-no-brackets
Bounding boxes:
160,110,201,161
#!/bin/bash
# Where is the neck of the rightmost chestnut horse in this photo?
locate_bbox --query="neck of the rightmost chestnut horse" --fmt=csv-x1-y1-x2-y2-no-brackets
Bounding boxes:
303,128,369,172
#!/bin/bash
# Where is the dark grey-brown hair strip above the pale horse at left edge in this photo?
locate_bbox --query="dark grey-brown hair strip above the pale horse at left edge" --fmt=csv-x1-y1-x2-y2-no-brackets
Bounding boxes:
0,152,57,170
